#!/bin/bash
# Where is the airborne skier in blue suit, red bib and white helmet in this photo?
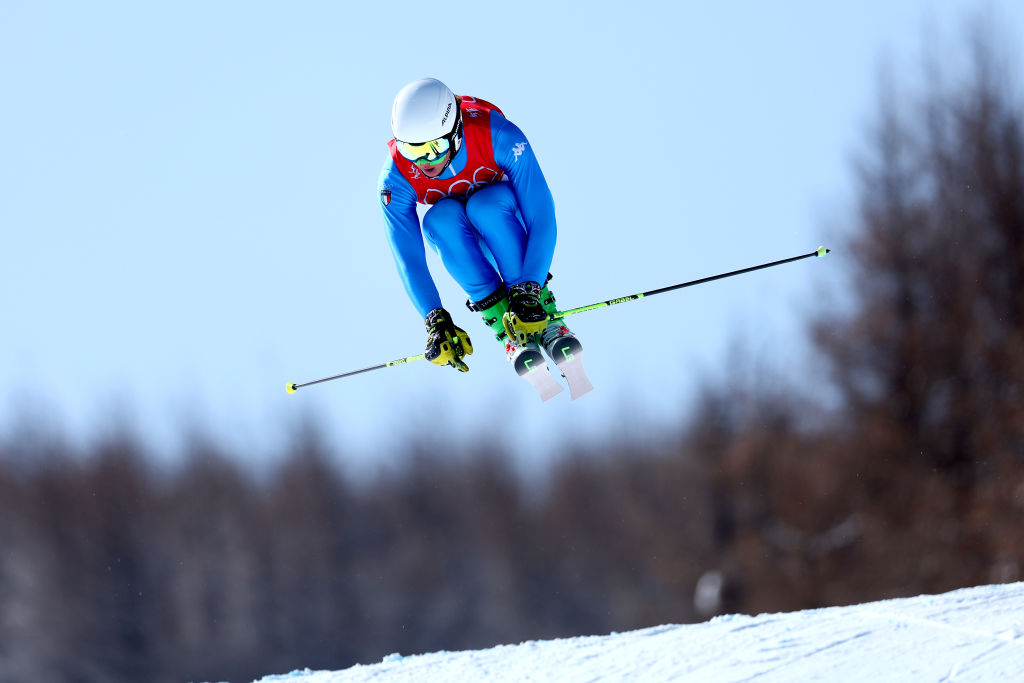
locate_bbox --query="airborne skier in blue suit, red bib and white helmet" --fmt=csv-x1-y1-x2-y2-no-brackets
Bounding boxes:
378,78,589,399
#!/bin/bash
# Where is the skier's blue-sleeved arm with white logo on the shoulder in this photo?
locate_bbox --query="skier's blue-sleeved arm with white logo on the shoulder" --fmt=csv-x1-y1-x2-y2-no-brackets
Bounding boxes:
490,113,558,285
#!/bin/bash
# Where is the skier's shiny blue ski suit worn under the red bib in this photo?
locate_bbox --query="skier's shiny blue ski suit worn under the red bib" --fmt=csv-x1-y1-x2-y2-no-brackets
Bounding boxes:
378,97,557,317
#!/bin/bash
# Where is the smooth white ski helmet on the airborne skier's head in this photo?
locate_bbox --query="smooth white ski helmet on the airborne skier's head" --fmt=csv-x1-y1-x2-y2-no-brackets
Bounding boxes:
391,78,462,144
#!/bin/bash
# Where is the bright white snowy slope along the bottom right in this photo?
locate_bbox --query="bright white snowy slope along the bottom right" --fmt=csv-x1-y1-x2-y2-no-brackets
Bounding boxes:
253,583,1024,683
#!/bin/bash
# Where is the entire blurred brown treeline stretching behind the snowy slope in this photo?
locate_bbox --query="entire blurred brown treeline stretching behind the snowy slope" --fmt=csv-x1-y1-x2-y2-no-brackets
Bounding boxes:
0,21,1024,682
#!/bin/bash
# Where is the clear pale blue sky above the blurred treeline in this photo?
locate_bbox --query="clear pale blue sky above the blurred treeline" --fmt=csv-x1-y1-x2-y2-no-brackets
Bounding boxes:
0,0,1024,471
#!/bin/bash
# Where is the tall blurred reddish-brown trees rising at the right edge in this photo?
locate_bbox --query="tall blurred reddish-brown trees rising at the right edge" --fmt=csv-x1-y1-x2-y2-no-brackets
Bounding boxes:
816,22,1024,592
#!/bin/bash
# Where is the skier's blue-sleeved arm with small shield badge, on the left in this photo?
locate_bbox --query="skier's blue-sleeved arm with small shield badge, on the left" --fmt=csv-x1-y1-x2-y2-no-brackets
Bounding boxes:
377,160,441,317
